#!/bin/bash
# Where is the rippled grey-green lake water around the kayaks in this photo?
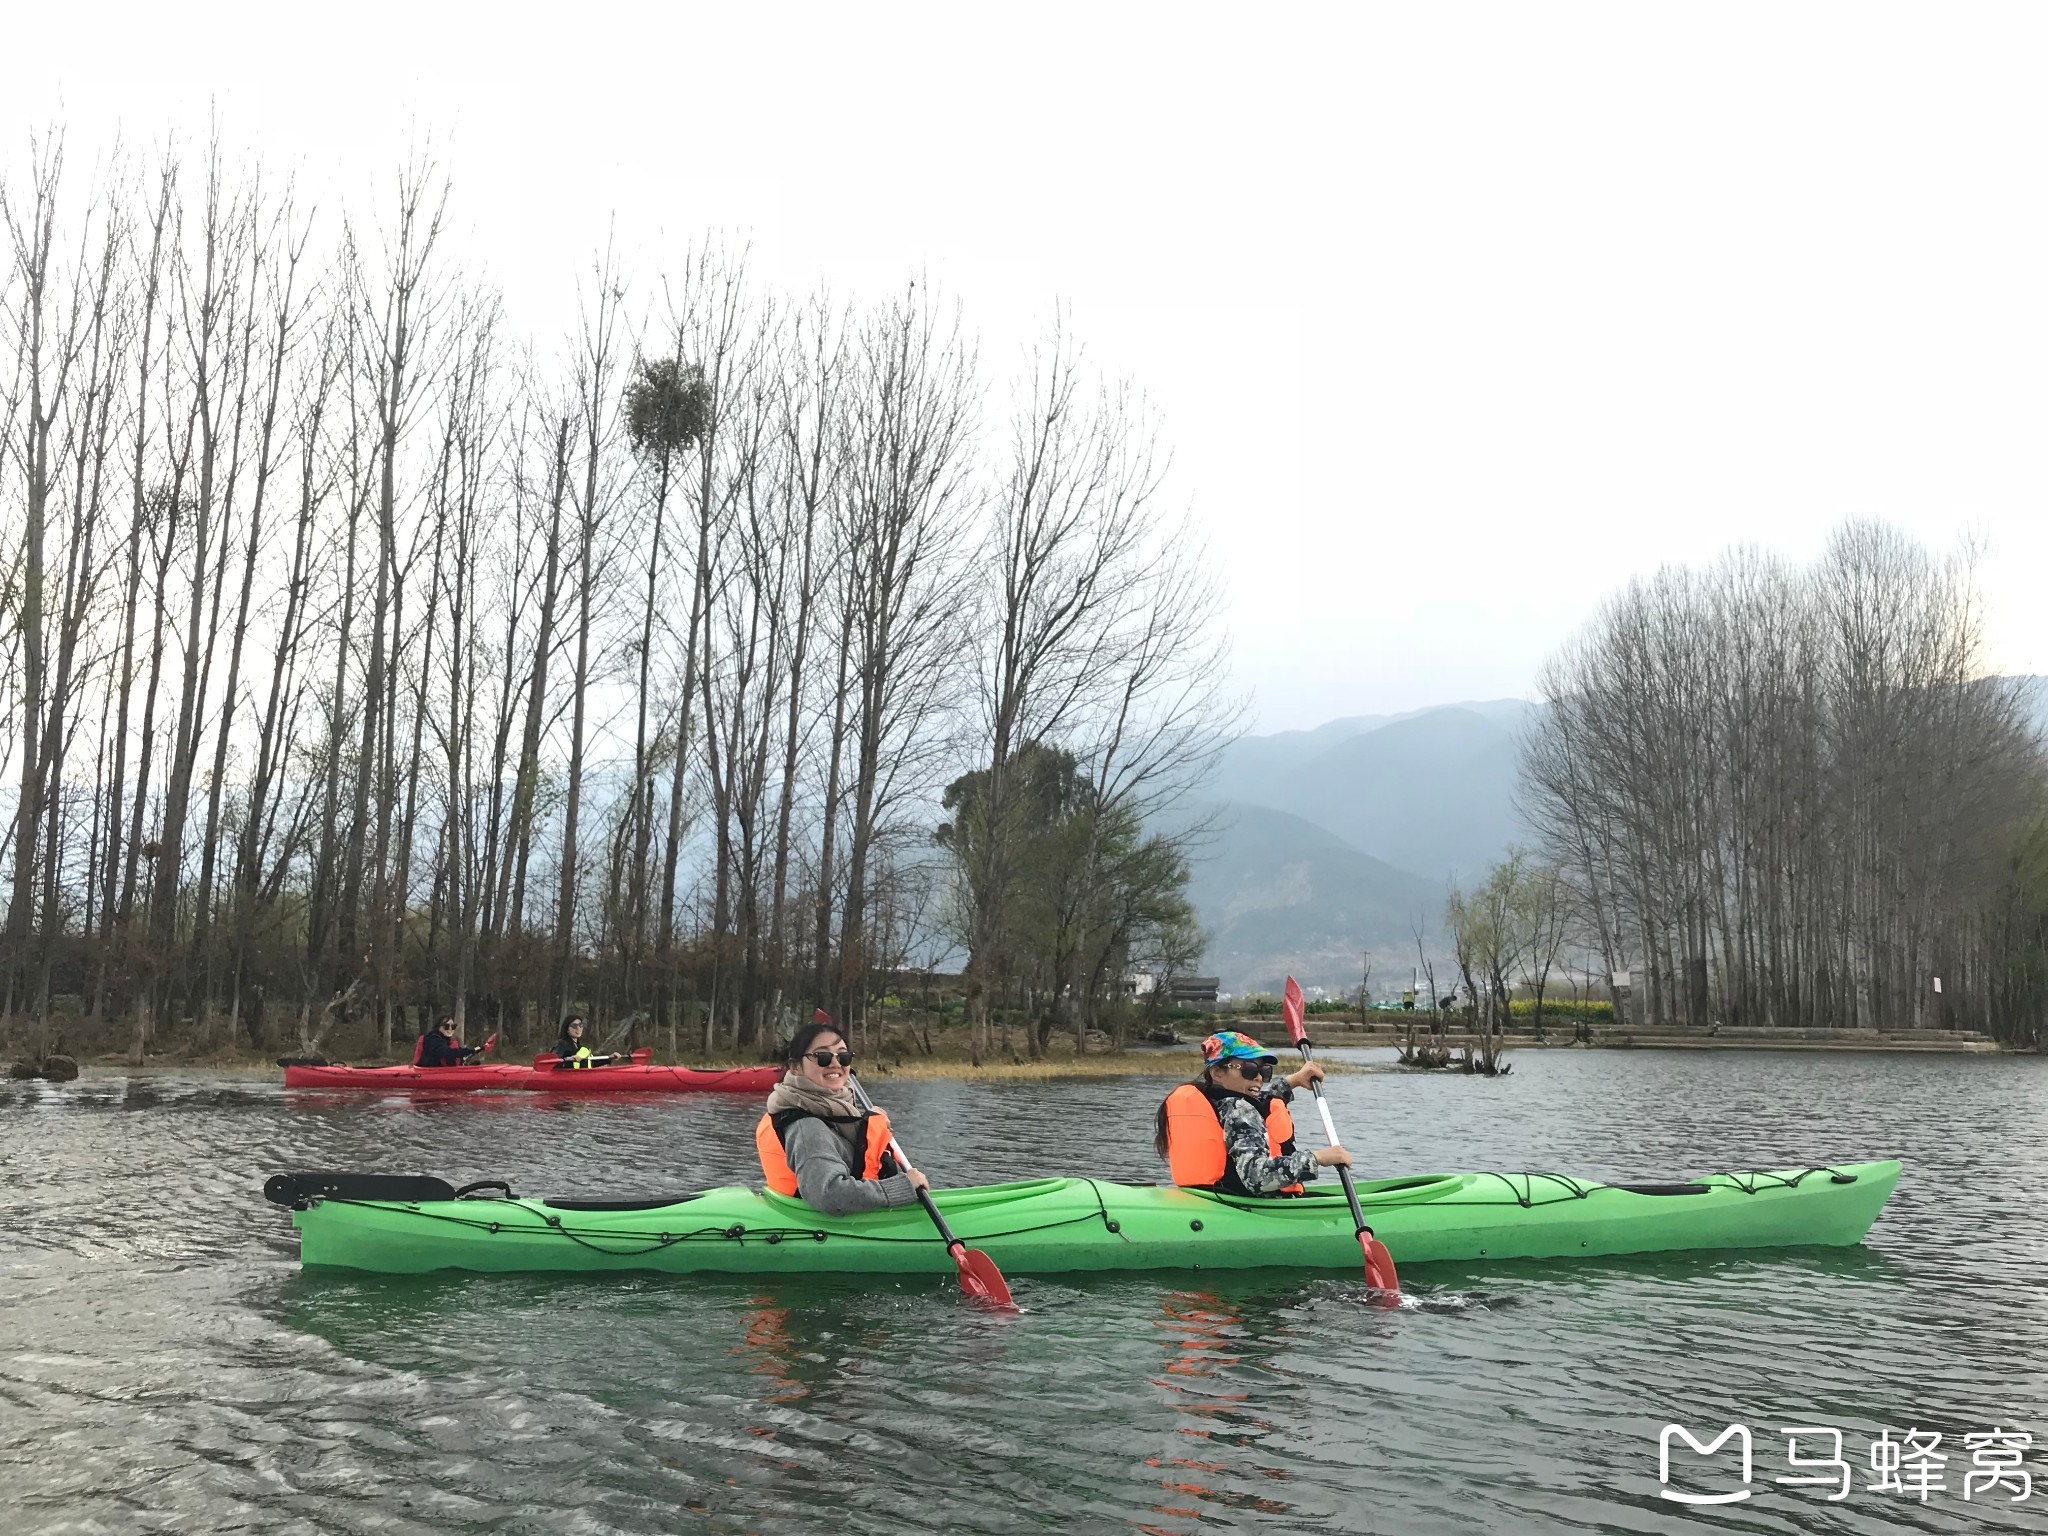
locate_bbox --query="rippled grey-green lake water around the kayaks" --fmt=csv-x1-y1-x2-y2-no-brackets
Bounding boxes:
0,1051,2048,1536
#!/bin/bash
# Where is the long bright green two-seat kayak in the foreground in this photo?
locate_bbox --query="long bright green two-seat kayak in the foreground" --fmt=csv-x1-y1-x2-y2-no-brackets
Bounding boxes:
264,1163,1898,1274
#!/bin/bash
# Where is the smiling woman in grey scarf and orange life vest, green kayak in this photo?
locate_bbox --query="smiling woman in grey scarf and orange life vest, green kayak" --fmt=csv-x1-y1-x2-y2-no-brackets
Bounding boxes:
754,1022,928,1217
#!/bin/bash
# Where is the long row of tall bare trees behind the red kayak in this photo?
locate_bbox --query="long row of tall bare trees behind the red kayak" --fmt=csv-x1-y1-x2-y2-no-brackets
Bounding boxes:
0,137,1261,1057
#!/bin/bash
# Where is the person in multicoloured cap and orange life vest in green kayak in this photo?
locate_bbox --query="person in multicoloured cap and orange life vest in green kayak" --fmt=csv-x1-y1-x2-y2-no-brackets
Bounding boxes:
1153,1030,1352,1196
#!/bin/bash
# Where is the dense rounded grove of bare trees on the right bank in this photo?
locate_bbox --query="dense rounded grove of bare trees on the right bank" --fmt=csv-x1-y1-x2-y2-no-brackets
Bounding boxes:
1522,524,2044,1032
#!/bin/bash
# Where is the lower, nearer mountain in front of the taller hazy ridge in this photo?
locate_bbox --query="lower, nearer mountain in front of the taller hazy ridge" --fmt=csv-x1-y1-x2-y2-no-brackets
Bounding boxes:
1188,803,1444,991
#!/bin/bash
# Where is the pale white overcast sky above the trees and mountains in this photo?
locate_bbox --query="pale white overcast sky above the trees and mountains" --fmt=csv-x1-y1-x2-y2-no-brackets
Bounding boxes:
19,0,2048,729
